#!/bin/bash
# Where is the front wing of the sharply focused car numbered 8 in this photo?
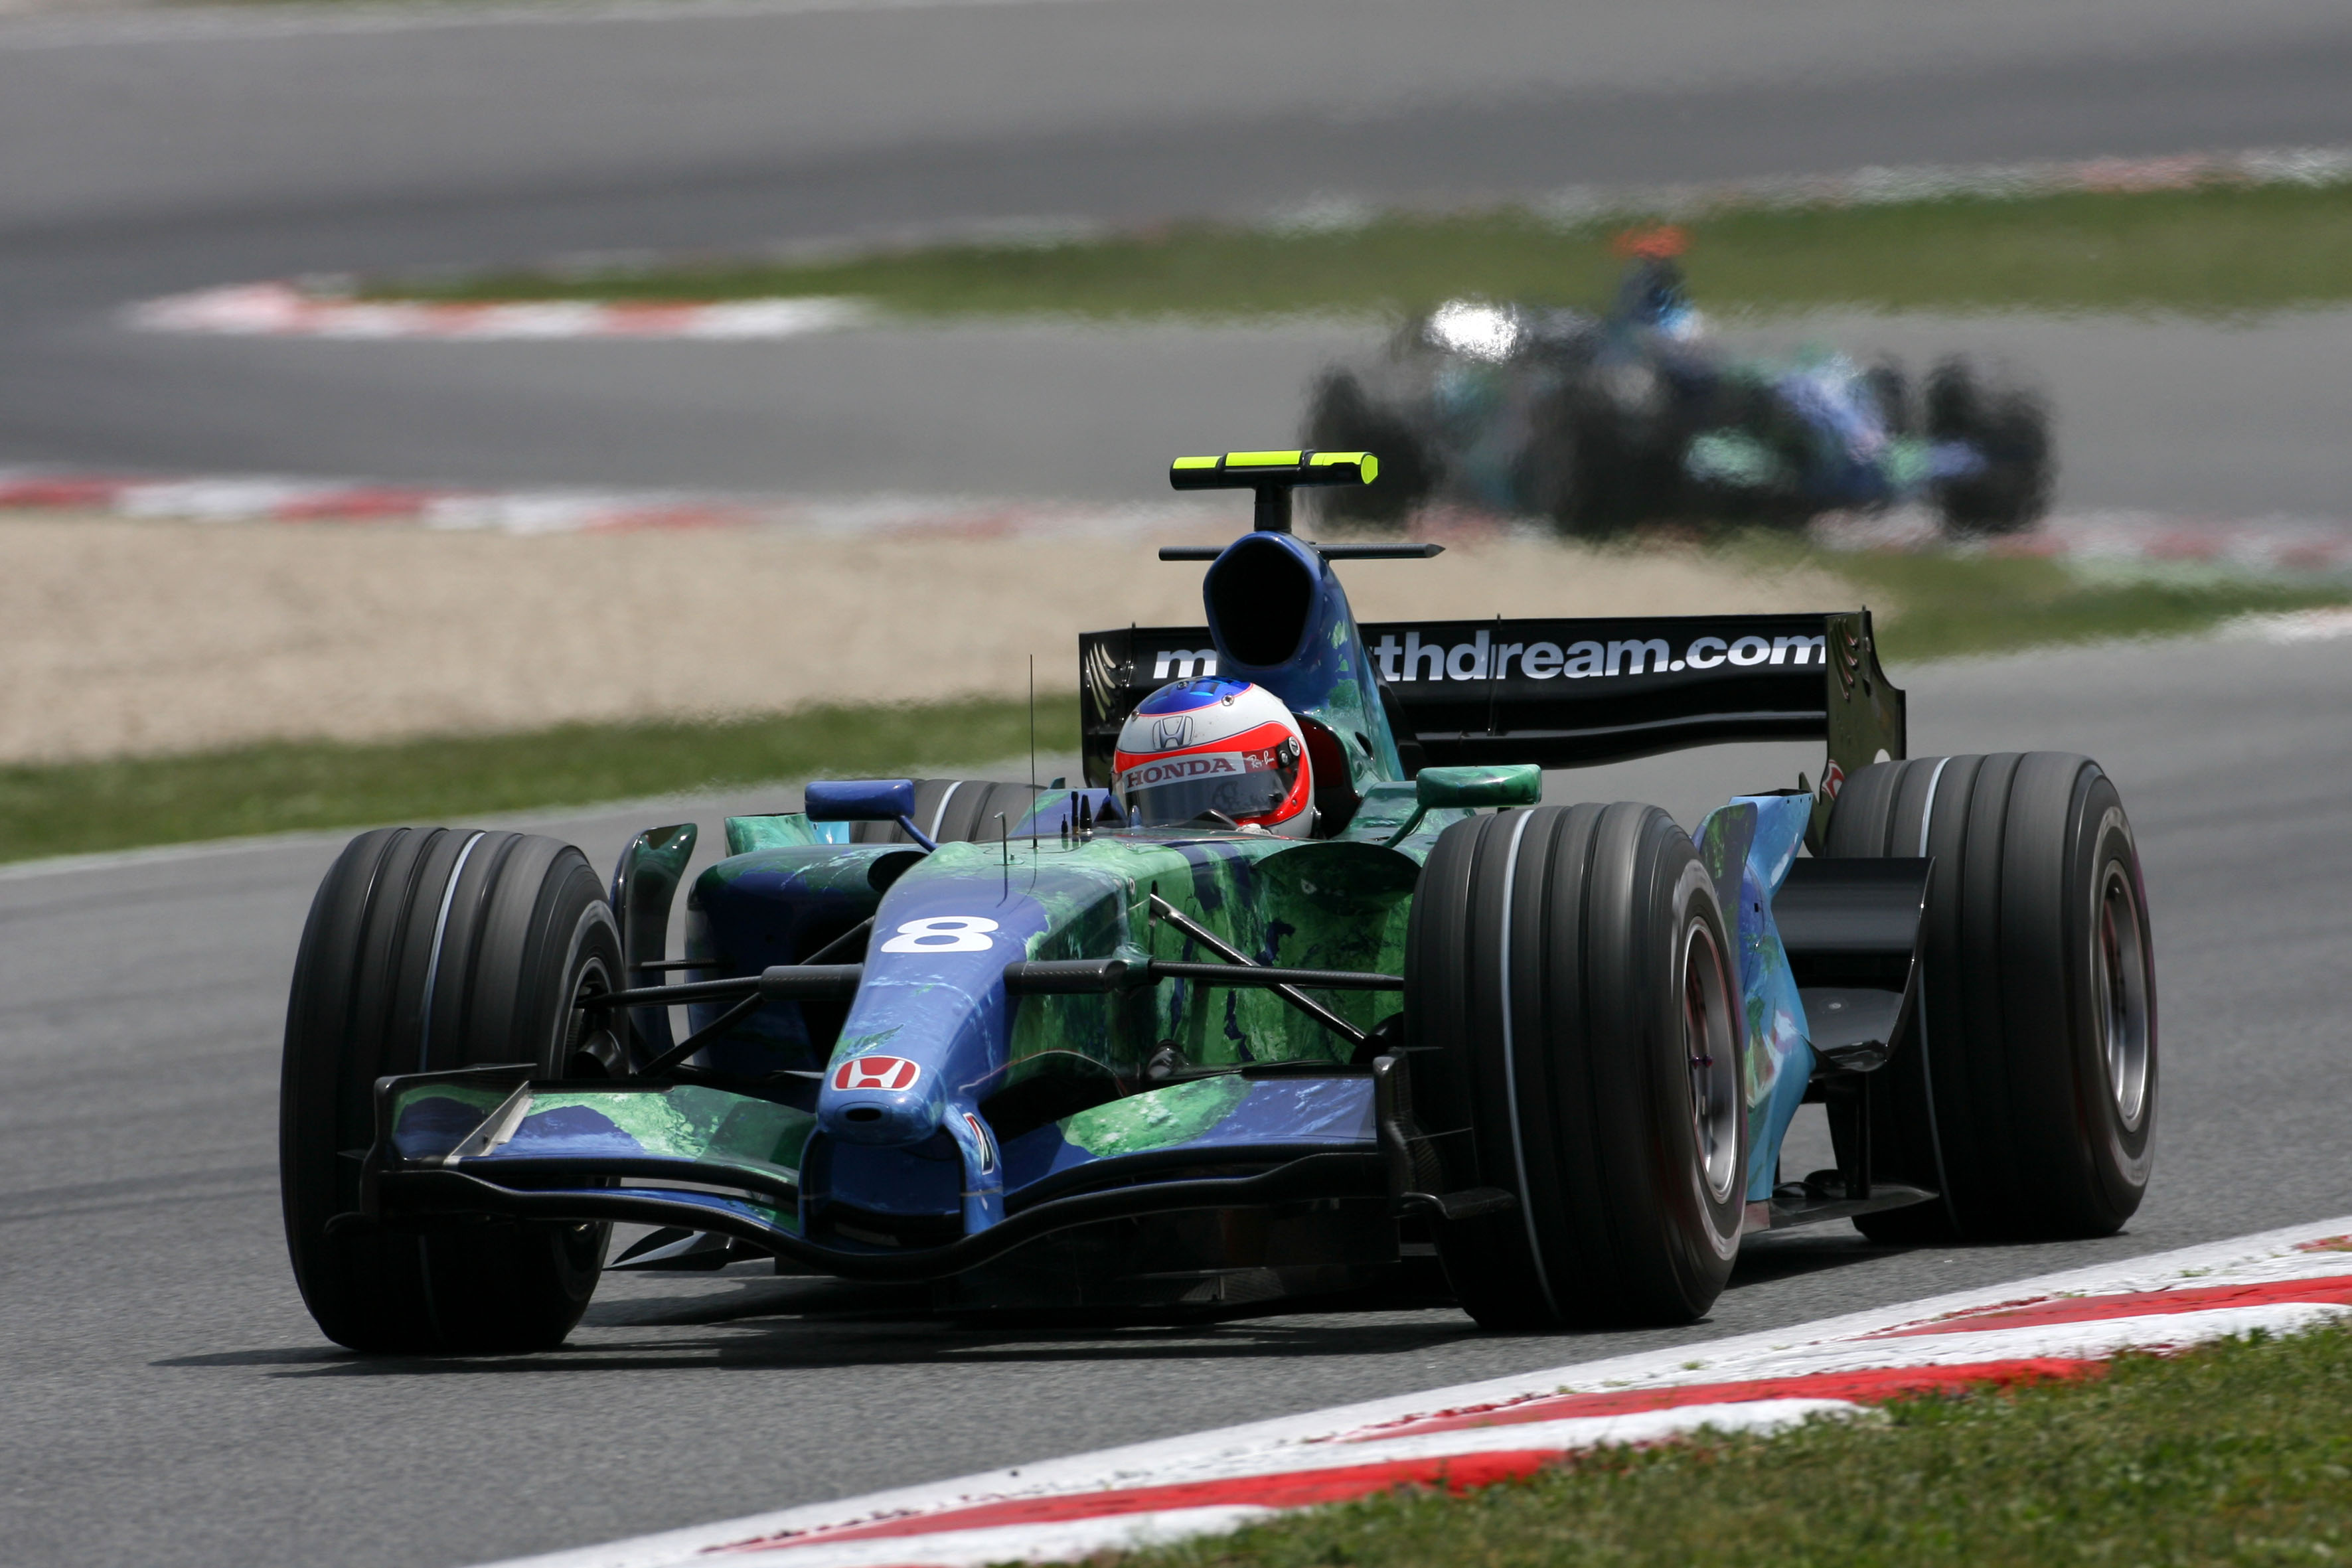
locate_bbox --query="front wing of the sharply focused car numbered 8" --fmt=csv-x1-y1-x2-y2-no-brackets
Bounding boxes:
332,1058,1449,1281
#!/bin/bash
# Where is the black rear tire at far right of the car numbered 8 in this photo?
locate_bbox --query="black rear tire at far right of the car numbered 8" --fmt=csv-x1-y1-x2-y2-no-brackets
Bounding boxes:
1825,752,2157,1241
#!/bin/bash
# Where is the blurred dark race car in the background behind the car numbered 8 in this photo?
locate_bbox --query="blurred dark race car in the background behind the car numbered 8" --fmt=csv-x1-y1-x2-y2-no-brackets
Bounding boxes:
1308,240,2051,536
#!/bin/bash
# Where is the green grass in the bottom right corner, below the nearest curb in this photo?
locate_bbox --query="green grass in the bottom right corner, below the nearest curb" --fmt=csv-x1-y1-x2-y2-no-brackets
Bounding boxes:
1119,1328,2352,1568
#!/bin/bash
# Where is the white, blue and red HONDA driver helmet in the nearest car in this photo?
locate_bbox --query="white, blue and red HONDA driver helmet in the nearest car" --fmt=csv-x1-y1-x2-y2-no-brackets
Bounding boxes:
1110,674,1315,839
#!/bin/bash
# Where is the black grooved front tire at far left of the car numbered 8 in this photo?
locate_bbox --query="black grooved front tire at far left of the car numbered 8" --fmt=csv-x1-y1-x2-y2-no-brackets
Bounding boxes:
277,828,621,1354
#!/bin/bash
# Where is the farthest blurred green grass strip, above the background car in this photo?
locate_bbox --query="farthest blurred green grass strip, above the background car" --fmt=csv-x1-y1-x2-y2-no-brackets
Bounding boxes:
376,183,2352,317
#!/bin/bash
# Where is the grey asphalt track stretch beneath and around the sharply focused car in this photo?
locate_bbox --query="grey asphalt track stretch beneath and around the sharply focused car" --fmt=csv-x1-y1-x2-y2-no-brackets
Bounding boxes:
0,642,2352,1565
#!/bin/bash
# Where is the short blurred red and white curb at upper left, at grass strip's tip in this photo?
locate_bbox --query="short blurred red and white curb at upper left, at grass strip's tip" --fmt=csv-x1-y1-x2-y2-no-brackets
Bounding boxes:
125,282,872,343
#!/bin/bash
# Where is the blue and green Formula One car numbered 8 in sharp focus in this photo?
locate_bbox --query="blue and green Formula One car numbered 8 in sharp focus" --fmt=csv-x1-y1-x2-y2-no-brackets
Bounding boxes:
280,451,2157,1352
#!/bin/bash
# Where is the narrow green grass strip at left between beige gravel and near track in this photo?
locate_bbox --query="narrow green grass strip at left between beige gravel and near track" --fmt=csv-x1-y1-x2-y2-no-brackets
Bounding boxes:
0,696,1077,860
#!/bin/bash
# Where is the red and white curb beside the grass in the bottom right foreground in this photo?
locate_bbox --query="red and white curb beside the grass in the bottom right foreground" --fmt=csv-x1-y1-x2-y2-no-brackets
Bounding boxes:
487,1215,2352,1568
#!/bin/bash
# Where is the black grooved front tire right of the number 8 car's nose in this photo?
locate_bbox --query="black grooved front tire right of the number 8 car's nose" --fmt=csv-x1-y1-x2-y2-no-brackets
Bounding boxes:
1404,804,1747,1330
